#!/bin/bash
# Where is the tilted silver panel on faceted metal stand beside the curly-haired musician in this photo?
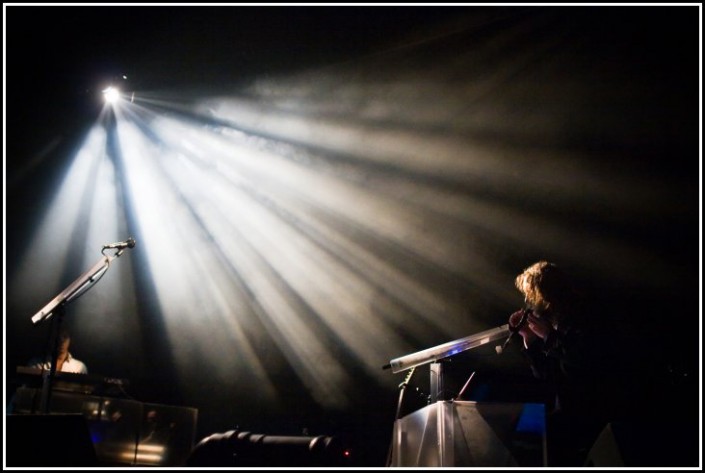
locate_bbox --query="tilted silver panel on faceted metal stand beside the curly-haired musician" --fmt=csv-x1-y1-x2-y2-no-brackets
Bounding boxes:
384,325,547,467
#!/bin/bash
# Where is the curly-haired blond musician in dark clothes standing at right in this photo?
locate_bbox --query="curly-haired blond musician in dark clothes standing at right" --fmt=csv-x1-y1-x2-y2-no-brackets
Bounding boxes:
509,261,609,467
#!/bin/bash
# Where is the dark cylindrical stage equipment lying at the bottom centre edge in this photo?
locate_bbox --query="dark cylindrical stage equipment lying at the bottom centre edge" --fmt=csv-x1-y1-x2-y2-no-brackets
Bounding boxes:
186,430,349,467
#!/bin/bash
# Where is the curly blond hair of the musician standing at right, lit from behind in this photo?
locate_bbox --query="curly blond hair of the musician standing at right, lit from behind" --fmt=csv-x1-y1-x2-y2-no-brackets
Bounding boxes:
514,261,573,312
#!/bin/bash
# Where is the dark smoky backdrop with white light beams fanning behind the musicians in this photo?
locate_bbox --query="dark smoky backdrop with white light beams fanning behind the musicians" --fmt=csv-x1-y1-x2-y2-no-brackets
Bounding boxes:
4,6,701,466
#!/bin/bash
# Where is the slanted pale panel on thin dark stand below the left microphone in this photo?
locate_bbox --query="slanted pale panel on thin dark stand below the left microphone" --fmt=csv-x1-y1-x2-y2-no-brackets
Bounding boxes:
32,249,124,414
